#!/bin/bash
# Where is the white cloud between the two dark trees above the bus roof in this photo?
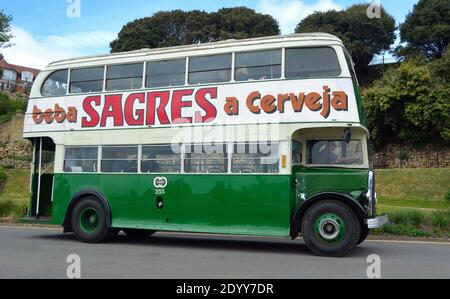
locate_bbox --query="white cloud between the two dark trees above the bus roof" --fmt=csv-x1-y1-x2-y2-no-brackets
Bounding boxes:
257,0,342,34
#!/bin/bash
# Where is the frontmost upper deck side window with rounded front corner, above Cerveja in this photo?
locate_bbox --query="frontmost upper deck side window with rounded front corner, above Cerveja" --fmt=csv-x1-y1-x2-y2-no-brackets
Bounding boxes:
286,47,341,79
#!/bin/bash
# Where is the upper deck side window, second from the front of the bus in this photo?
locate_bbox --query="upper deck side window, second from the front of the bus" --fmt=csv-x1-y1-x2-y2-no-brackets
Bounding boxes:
235,50,281,81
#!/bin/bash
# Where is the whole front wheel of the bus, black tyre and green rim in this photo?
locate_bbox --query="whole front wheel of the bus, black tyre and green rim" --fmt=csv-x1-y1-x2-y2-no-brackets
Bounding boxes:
302,200,361,257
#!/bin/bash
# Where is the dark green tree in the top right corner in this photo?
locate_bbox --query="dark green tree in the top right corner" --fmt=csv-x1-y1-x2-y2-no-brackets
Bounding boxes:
397,0,450,60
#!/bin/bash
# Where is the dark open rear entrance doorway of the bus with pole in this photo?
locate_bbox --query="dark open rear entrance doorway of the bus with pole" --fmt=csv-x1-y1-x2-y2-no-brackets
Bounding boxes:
27,137,55,220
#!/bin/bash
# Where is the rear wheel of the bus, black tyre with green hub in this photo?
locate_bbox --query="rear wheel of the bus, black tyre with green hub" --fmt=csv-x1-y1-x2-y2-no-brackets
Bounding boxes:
71,197,115,243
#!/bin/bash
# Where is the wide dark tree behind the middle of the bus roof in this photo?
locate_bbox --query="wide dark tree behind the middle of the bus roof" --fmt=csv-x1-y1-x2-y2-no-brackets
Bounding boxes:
111,7,280,52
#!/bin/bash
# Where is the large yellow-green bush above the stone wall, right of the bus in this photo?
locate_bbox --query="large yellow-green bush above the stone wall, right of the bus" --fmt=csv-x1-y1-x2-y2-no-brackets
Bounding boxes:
363,61,450,146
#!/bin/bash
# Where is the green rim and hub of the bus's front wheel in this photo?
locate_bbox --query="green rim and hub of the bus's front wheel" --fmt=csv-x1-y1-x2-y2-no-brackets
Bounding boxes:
314,213,347,243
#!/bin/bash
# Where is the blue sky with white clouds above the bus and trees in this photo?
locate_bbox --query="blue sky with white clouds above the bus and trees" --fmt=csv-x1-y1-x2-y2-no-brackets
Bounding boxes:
0,0,418,68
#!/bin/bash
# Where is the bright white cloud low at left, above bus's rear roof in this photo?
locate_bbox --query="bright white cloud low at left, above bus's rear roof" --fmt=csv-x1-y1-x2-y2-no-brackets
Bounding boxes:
1,27,116,69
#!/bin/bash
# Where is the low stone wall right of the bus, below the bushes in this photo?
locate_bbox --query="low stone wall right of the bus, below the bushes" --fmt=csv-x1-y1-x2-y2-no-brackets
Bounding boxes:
371,144,450,169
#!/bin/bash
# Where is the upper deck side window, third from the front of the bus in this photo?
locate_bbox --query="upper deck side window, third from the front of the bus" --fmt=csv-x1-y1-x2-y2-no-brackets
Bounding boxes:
189,54,231,84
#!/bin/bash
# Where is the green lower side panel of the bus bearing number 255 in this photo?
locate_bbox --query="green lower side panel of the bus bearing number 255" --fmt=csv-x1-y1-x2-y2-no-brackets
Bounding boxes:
53,174,295,236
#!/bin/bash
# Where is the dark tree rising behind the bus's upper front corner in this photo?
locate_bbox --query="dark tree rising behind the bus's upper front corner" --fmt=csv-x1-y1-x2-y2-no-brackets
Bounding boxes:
295,4,396,81
